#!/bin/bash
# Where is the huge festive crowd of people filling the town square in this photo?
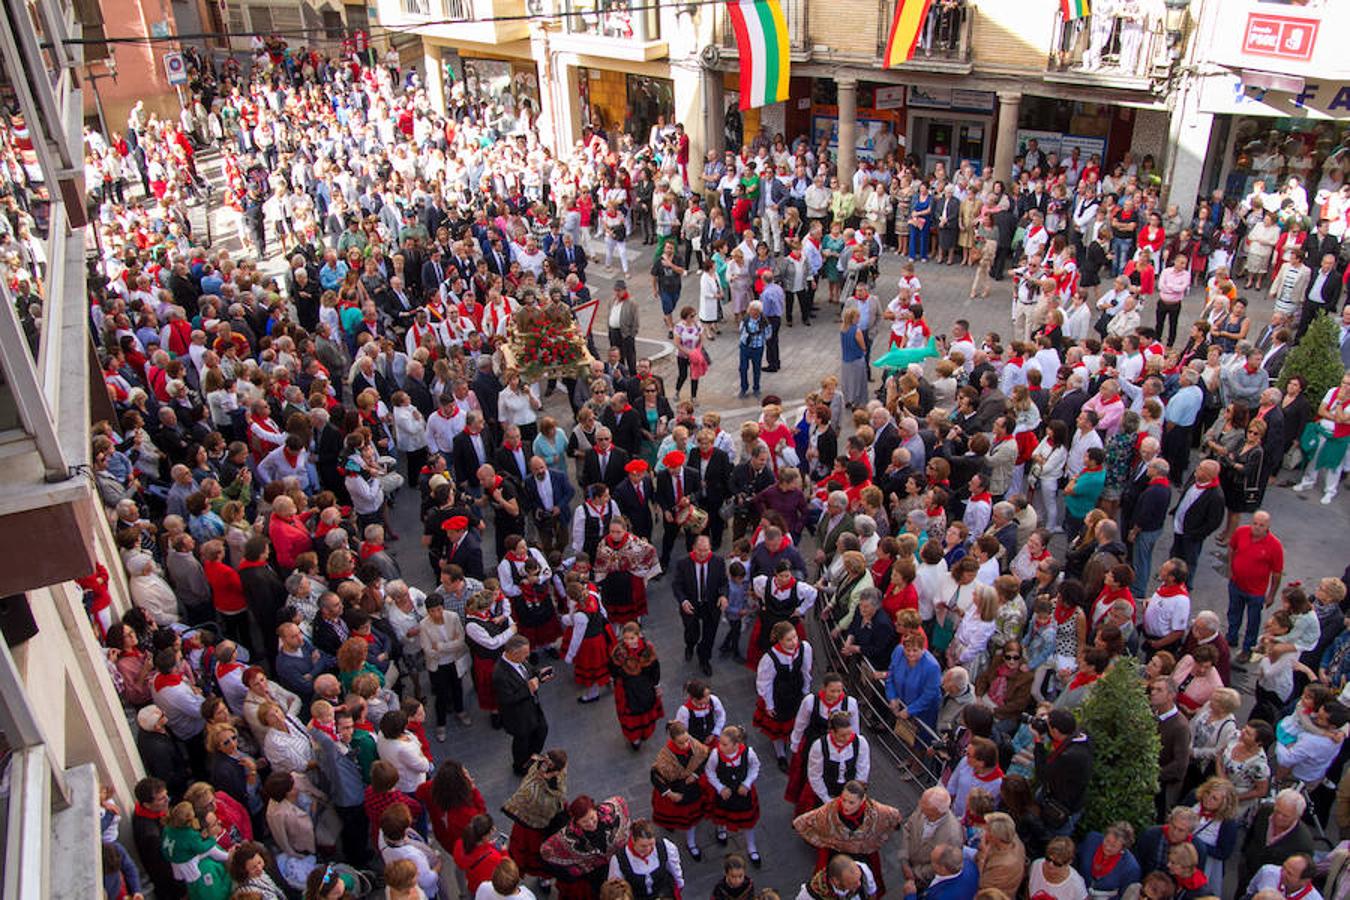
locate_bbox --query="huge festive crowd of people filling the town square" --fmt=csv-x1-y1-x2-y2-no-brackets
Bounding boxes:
34,19,1350,900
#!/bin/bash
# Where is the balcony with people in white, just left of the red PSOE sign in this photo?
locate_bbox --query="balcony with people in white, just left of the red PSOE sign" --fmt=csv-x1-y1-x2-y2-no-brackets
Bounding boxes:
1045,12,1172,90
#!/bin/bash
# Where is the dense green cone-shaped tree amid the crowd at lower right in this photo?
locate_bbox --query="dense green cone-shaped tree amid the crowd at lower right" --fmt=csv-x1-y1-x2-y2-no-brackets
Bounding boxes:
1079,657,1161,833
